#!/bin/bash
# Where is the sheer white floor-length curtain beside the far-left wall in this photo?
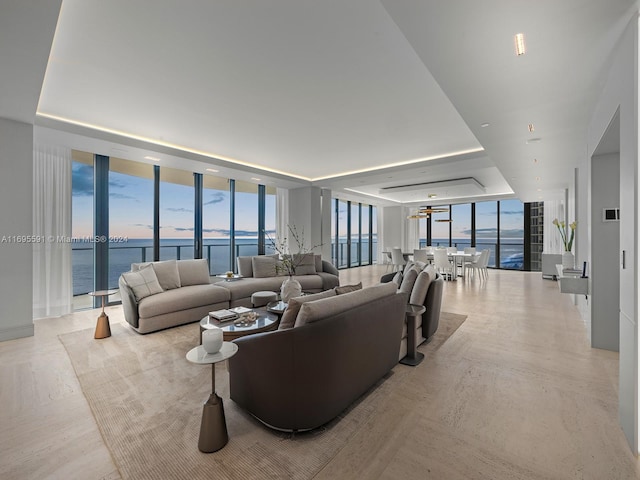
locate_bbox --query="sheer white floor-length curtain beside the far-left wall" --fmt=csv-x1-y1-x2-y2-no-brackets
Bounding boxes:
33,145,73,318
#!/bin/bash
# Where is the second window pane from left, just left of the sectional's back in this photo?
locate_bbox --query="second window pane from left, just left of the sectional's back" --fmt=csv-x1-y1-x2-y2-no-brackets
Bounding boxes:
109,158,154,288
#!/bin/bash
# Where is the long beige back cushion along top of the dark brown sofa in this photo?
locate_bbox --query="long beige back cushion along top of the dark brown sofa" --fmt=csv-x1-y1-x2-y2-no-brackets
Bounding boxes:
294,283,396,328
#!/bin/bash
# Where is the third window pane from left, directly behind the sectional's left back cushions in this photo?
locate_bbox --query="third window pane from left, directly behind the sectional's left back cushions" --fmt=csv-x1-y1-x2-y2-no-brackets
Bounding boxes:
160,167,194,260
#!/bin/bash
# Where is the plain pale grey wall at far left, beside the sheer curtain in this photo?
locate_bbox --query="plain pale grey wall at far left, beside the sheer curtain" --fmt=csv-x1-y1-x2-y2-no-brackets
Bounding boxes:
0,118,33,341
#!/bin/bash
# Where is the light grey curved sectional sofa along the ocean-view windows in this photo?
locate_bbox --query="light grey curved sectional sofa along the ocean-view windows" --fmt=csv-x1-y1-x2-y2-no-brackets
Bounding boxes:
118,255,340,333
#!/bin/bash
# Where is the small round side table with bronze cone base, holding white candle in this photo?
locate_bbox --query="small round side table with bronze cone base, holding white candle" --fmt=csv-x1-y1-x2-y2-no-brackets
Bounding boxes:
187,342,238,453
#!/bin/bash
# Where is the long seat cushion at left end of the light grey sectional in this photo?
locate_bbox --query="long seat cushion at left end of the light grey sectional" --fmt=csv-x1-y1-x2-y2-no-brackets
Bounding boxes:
138,283,229,318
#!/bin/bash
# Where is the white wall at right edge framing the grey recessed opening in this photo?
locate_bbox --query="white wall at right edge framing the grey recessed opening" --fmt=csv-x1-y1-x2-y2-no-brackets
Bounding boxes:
578,15,638,454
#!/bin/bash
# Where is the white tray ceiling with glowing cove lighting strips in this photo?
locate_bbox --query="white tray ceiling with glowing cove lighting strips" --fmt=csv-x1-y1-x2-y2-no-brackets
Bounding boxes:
6,0,637,203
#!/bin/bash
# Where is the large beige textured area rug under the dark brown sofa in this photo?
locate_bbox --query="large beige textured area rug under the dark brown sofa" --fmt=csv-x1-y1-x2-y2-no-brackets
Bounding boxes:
59,312,466,480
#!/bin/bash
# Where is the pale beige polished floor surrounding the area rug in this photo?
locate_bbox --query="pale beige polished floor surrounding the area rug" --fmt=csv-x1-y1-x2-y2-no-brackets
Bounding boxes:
0,266,640,480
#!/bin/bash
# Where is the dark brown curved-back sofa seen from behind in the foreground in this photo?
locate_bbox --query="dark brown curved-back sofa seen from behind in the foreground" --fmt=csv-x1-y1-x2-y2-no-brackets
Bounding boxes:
229,284,407,431
